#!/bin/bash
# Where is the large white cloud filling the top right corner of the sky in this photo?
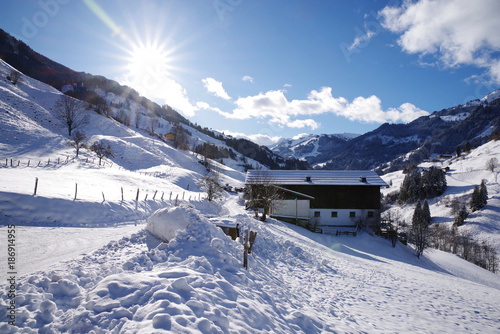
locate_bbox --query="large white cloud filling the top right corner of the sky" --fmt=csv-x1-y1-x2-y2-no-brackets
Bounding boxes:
380,0,500,82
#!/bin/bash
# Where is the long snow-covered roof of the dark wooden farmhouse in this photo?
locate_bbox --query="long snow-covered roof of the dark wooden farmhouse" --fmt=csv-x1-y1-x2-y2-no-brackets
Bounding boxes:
245,169,387,186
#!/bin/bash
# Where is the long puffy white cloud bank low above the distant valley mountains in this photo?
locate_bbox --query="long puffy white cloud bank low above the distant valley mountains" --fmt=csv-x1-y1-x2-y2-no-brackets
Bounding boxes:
219,87,428,130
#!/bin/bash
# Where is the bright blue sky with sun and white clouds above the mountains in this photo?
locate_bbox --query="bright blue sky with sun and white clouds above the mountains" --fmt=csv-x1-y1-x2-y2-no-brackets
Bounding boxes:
0,0,500,144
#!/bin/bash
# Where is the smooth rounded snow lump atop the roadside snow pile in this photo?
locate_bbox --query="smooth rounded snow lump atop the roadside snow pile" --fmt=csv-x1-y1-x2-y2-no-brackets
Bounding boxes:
146,204,200,242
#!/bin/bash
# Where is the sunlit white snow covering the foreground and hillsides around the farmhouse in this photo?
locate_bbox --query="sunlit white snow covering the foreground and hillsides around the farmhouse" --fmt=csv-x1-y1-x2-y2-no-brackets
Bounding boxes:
0,58,500,333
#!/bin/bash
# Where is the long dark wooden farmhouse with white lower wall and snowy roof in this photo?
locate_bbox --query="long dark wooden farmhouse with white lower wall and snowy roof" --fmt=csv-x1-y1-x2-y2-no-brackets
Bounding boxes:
245,170,387,233
